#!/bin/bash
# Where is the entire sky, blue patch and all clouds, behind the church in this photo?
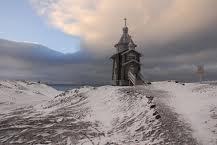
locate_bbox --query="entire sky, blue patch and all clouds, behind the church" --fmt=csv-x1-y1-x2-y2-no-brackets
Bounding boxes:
0,0,217,83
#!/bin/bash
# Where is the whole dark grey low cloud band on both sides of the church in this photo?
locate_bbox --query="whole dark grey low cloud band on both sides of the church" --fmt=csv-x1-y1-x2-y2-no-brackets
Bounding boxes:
0,32,217,84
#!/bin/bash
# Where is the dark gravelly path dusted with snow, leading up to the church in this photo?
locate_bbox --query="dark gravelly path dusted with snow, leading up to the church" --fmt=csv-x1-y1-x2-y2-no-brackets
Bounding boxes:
137,85,199,145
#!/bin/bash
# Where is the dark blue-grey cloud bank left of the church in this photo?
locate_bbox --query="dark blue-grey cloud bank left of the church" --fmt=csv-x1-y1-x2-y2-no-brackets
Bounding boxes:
0,39,111,83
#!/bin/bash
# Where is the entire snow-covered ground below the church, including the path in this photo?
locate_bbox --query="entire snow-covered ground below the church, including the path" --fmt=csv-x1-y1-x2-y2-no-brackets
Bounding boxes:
0,81,217,145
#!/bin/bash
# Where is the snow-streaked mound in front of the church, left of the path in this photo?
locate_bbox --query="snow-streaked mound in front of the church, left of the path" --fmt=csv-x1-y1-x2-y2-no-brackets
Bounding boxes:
0,86,166,145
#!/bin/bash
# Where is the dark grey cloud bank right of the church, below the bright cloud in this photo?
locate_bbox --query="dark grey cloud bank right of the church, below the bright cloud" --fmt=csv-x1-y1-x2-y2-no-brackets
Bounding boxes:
140,23,217,81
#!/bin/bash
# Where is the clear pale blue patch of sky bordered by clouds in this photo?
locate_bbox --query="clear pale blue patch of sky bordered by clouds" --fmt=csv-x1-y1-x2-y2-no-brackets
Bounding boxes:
0,0,80,53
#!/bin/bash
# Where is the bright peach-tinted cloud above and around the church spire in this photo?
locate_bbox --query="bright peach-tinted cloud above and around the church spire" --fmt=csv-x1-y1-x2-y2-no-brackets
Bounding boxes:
32,0,217,55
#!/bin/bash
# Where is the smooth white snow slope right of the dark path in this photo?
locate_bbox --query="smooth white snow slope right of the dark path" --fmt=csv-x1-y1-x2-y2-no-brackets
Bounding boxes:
152,82,217,145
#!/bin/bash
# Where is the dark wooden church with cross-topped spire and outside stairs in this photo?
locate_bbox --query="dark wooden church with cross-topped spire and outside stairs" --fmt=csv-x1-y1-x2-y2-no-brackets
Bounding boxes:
111,19,144,86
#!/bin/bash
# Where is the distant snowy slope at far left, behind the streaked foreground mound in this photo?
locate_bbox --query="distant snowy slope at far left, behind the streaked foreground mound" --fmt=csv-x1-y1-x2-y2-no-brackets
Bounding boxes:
0,81,60,113
